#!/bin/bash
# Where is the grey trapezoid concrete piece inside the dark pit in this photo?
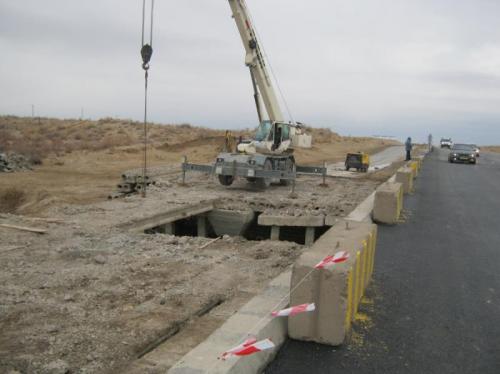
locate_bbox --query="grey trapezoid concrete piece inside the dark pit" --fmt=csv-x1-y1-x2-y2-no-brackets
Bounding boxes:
207,209,255,236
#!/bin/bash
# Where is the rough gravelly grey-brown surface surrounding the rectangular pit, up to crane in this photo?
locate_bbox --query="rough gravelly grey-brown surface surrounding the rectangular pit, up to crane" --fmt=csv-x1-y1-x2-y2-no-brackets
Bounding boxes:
0,171,377,373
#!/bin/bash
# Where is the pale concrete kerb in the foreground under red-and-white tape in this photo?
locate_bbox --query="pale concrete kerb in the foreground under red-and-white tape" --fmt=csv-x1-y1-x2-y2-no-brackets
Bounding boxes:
168,271,291,374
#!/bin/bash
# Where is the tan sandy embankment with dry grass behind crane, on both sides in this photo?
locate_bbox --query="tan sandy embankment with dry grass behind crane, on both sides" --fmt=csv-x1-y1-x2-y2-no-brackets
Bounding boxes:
0,116,394,214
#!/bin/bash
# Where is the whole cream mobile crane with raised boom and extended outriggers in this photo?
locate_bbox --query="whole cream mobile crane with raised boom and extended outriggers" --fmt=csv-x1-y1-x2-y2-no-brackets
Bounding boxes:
182,0,326,188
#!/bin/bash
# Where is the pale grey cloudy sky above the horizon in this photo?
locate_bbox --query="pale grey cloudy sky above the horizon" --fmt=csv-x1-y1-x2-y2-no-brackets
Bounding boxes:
0,0,500,144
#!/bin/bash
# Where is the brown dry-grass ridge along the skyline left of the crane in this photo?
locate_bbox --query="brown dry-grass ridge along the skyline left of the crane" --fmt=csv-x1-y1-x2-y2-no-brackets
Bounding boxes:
0,116,236,164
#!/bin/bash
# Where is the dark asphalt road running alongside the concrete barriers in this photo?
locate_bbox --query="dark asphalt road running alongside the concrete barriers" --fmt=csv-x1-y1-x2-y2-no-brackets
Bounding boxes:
266,150,500,374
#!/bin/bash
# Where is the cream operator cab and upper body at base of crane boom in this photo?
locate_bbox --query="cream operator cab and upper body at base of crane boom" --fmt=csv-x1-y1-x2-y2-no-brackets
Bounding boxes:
238,121,292,154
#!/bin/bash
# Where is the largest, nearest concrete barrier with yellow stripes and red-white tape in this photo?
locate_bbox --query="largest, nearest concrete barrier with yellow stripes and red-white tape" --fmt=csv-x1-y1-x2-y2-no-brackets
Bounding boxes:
288,220,377,345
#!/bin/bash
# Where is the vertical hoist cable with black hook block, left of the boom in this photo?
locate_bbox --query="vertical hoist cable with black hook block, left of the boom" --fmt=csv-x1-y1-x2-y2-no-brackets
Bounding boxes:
141,0,155,197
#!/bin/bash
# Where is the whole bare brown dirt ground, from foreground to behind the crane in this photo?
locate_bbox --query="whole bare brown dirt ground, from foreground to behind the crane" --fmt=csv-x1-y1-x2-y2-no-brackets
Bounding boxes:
0,116,398,373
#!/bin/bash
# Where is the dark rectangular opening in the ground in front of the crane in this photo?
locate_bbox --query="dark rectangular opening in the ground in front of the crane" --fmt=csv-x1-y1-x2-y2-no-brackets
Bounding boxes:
144,211,330,245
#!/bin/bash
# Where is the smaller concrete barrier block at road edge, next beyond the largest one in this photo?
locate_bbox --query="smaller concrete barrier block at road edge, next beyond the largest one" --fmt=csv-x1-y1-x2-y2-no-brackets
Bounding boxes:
373,182,403,225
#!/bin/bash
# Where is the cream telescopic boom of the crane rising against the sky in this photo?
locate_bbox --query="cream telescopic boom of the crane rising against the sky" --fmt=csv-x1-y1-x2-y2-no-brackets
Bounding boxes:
229,0,284,122
